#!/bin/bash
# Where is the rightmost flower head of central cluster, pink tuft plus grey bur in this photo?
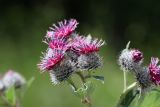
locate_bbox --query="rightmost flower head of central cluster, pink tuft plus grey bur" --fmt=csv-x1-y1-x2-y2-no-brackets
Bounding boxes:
70,35,105,71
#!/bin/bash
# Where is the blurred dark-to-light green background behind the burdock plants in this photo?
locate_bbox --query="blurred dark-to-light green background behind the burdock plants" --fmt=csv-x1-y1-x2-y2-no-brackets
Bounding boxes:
0,0,160,107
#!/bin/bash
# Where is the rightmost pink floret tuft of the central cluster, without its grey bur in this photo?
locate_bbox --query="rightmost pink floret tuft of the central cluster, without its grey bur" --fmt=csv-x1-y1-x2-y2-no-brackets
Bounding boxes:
72,35,105,54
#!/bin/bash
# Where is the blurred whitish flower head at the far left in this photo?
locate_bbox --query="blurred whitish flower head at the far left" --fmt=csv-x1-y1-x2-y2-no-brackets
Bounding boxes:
2,70,26,88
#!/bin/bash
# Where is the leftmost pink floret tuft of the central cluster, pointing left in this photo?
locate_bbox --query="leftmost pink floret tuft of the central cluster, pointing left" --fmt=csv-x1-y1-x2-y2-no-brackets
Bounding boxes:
38,48,64,71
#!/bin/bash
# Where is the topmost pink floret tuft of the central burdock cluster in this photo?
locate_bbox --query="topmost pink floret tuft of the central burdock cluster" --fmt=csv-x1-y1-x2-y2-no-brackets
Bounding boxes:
46,19,78,39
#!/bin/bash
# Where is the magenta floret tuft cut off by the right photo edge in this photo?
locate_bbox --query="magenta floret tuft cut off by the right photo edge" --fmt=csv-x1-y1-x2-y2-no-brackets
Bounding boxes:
149,57,160,85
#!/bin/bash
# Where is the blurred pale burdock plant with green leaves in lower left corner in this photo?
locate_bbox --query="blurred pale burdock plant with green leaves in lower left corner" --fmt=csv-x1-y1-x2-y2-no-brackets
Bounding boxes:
0,70,33,107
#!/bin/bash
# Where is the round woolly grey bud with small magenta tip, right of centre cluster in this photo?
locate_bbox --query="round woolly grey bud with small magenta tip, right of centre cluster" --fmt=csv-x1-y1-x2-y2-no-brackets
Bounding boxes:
118,49,143,71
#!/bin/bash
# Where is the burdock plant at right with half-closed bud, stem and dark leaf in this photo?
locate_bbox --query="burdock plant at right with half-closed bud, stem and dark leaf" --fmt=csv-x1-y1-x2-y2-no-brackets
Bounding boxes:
117,42,160,107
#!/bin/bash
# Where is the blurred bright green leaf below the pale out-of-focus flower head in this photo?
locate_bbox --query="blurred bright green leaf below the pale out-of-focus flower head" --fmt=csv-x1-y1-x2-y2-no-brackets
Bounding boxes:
5,86,16,106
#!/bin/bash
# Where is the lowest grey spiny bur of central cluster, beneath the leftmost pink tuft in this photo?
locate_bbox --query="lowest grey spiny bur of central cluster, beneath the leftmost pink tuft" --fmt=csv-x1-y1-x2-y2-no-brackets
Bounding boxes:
50,60,76,84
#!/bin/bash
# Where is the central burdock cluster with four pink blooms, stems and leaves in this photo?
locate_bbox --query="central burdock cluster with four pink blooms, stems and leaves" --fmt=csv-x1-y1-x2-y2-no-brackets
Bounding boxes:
38,19,105,106
